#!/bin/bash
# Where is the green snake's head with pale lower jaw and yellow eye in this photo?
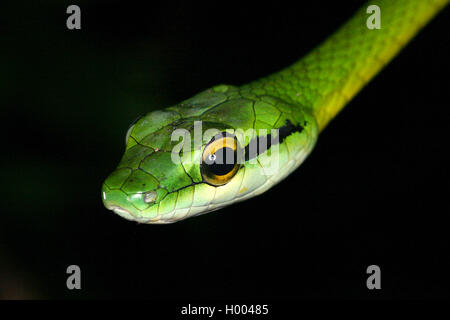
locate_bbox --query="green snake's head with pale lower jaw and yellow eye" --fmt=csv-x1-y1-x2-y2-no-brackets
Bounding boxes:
102,85,317,223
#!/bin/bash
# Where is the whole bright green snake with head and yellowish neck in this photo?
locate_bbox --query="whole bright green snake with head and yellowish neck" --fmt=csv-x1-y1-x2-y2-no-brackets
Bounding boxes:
102,0,449,223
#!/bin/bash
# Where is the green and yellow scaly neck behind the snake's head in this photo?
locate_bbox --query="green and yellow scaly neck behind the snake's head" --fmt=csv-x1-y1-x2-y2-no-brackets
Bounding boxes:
241,0,449,131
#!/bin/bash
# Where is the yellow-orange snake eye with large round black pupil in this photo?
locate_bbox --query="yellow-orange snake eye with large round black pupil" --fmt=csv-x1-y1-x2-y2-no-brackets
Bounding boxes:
201,135,240,186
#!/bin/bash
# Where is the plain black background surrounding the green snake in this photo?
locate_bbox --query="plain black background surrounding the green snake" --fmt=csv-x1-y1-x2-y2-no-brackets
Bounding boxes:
0,0,450,301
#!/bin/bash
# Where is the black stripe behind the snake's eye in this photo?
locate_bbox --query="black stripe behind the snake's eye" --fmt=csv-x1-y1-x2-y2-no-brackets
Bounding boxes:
244,120,306,161
